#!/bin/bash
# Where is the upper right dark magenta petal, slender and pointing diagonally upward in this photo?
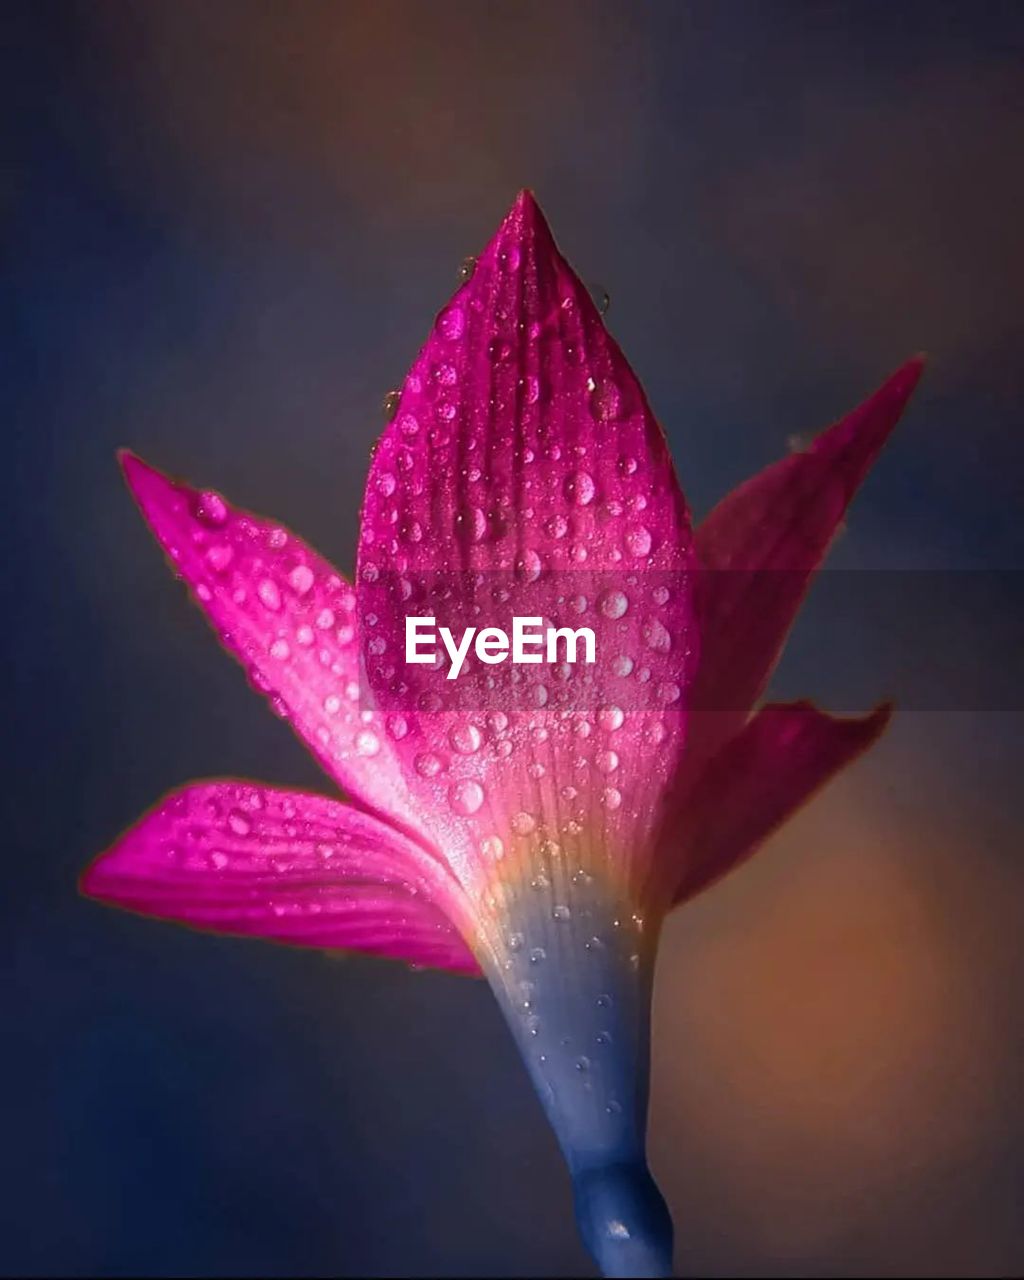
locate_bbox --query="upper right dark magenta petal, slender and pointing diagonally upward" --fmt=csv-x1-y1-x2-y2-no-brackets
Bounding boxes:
694,357,924,749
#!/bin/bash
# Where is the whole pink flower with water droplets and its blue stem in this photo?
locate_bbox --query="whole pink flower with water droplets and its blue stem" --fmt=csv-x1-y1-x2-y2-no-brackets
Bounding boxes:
82,192,922,1275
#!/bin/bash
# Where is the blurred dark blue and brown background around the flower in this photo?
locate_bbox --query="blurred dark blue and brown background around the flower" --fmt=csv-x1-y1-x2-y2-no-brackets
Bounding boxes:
8,0,1024,1276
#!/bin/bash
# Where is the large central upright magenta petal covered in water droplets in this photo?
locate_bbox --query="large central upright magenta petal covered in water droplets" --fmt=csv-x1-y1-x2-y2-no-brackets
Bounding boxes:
357,192,695,906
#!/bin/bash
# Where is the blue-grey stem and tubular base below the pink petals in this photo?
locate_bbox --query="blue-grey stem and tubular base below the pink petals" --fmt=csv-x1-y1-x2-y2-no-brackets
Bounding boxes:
489,888,672,1276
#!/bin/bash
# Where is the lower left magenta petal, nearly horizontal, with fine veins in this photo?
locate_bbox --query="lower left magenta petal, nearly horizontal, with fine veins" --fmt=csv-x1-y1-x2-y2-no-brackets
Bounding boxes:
82,781,477,973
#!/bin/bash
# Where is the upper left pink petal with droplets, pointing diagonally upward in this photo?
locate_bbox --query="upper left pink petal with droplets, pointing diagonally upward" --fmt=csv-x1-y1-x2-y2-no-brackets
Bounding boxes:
122,453,421,831
